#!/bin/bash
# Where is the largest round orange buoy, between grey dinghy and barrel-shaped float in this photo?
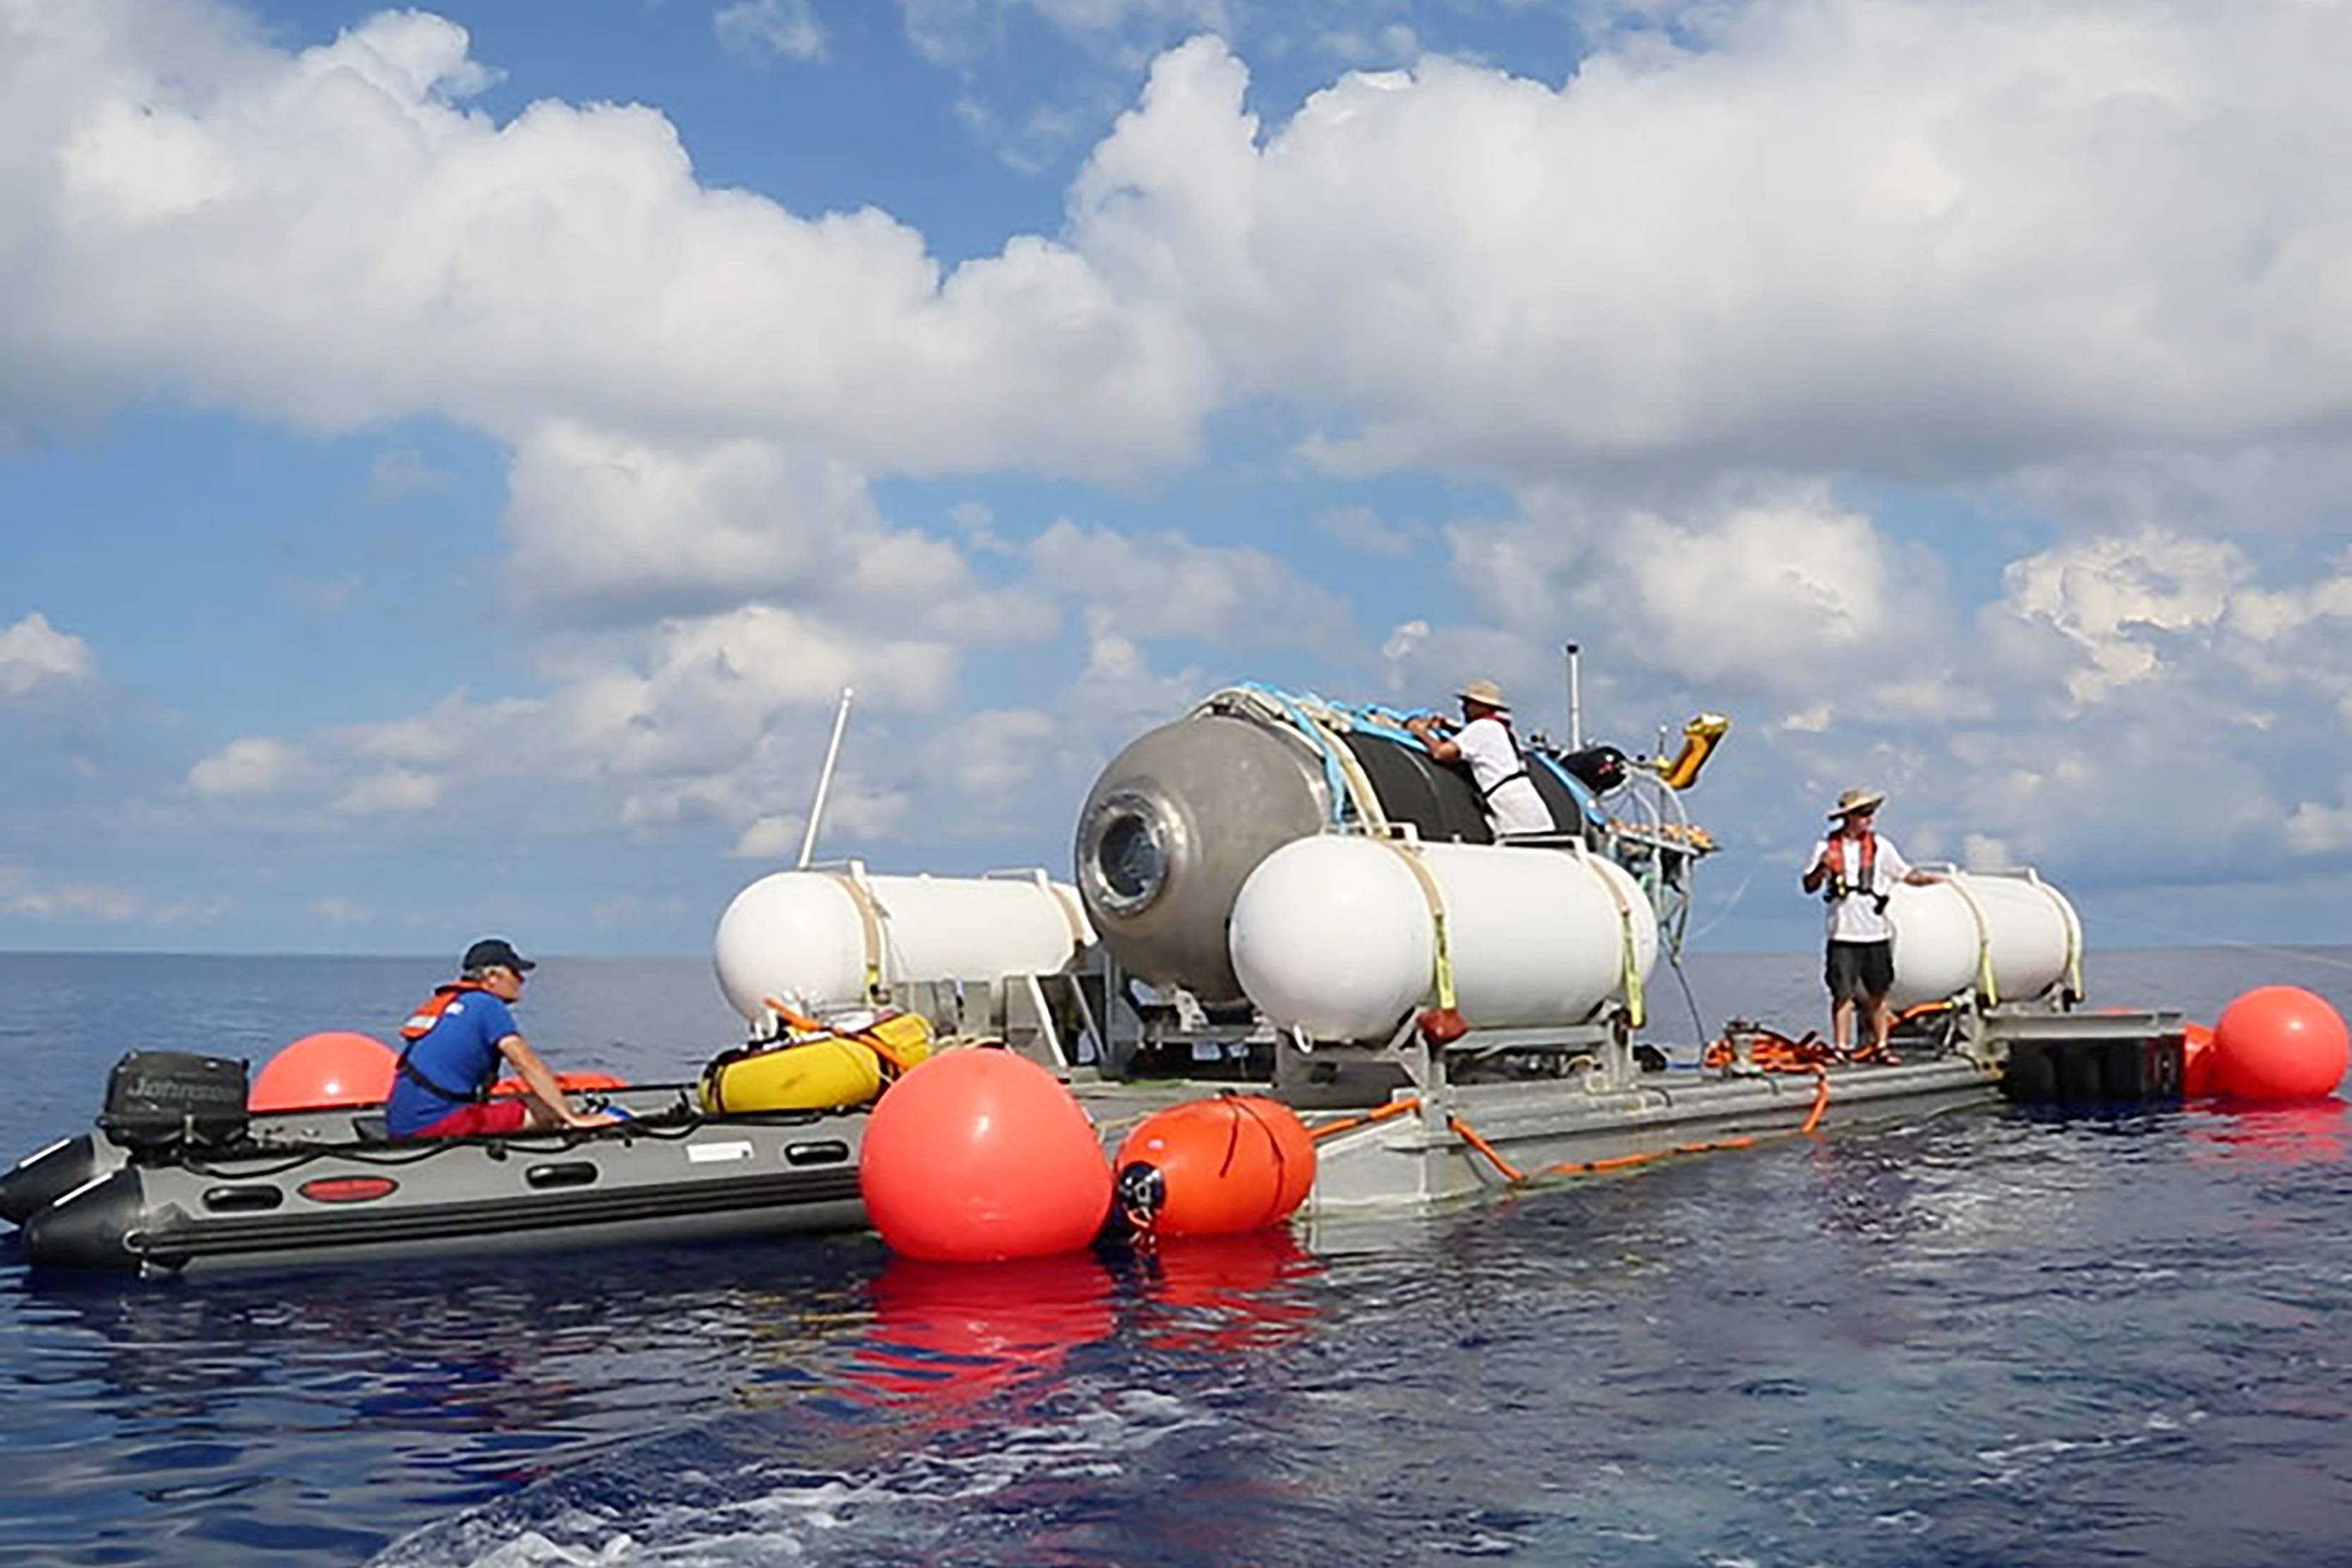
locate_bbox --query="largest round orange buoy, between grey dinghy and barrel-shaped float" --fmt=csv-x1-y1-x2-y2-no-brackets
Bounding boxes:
859,1049,1110,1262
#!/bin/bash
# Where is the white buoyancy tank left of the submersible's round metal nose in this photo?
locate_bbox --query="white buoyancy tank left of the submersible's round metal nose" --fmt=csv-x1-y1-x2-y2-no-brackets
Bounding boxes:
713,863,1094,1023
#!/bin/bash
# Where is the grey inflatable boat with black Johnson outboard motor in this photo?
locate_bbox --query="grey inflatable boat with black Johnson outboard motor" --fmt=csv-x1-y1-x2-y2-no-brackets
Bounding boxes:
0,1053,866,1274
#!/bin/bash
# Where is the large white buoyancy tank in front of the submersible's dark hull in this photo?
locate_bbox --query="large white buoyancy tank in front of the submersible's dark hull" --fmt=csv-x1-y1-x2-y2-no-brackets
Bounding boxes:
1230,835,1658,1042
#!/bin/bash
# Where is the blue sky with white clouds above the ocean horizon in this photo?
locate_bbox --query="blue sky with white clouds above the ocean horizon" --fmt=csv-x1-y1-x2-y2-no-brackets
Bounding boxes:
0,0,2352,955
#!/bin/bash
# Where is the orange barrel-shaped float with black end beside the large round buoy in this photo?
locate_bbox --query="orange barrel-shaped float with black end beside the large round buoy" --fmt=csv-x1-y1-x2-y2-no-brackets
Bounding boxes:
1113,1095,1315,1236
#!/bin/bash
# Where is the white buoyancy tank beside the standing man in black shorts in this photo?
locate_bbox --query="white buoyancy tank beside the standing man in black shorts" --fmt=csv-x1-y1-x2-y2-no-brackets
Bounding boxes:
1886,872,2082,1008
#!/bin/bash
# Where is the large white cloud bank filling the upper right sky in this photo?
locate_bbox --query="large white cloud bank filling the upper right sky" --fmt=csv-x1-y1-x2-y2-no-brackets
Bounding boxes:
1073,0,2352,475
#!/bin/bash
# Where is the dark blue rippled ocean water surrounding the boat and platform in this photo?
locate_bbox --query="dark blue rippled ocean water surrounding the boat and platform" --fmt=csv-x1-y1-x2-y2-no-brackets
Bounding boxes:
0,948,2352,1568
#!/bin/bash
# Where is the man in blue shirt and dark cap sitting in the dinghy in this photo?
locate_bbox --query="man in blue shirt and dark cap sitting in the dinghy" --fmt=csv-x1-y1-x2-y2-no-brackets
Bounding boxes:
383,936,614,1138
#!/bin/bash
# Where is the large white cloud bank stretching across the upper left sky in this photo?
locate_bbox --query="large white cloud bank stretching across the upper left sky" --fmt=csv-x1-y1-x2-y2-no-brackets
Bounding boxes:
0,0,1211,475
